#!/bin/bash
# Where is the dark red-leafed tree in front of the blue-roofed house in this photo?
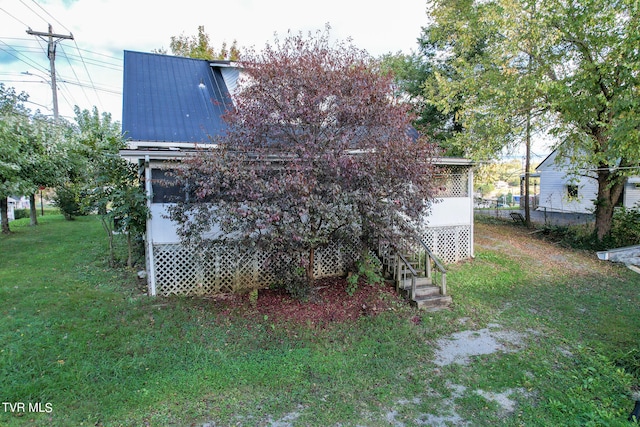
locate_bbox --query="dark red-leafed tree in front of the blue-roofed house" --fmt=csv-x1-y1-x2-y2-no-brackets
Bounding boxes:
171,28,434,294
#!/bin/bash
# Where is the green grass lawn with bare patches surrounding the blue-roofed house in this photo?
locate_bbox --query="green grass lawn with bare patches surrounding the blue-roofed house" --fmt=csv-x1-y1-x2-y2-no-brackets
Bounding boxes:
0,215,640,426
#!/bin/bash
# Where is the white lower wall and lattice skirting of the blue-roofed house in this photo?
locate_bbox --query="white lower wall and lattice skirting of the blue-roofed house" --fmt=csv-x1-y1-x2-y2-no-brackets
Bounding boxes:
147,198,473,295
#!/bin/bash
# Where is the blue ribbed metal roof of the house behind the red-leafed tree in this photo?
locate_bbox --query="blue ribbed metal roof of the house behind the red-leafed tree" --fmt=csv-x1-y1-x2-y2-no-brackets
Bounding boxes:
122,51,233,143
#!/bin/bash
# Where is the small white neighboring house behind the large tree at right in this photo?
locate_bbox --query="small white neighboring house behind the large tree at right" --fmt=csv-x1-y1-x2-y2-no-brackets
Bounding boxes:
536,150,640,213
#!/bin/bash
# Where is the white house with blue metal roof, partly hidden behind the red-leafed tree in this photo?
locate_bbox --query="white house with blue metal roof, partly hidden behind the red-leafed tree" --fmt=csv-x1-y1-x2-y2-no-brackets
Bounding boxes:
121,51,473,295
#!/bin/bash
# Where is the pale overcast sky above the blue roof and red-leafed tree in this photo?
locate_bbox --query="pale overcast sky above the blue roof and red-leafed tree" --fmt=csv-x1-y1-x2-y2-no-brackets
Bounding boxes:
0,0,427,121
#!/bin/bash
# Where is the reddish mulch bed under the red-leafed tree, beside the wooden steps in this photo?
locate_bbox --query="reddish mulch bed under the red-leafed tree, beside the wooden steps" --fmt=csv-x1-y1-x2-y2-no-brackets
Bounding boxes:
210,277,399,325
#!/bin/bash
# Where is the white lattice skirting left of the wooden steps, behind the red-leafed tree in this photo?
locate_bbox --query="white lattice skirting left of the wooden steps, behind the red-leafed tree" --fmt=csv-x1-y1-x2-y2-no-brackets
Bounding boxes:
153,242,358,296
